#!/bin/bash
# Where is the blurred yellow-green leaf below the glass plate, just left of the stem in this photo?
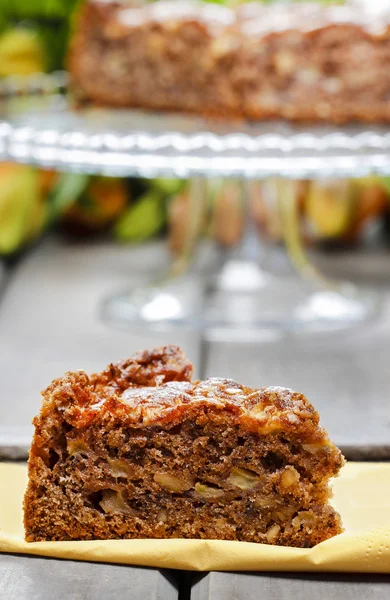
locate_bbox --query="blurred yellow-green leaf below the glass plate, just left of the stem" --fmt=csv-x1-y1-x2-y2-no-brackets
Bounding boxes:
114,190,165,242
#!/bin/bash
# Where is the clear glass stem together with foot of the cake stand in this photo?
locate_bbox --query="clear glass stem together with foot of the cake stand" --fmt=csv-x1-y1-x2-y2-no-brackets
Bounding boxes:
103,178,380,341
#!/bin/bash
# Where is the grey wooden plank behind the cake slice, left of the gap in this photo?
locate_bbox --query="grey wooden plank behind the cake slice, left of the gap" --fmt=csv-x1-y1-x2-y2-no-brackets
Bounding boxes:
0,239,200,458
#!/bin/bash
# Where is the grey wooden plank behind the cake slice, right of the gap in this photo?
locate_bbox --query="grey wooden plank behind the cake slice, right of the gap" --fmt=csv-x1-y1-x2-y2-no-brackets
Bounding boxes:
205,304,390,459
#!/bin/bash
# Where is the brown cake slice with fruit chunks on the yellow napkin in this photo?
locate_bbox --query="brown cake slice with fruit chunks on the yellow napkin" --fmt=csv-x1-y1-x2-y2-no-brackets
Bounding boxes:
24,346,344,547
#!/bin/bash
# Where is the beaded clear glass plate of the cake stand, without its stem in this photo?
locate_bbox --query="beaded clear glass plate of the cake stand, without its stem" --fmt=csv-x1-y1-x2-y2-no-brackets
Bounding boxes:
0,74,390,179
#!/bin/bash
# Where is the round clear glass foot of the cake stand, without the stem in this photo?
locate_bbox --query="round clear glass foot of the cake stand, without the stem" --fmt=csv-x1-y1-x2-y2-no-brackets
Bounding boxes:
103,260,381,341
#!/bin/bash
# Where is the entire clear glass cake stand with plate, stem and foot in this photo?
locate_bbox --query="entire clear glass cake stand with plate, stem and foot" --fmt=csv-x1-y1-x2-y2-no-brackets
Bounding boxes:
0,73,390,339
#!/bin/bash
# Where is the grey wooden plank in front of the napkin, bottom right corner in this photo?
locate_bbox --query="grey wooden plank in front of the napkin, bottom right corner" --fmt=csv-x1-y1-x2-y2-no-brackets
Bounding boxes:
191,573,390,600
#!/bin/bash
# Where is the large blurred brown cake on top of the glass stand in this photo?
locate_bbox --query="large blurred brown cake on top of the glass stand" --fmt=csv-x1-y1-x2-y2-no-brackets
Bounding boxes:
68,0,390,122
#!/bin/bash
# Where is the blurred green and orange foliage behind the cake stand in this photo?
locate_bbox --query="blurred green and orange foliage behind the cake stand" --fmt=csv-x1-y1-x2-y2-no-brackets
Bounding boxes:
0,0,390,257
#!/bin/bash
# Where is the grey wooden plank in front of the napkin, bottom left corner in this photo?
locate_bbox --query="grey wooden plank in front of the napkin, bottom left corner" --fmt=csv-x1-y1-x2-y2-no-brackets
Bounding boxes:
0,554,178,600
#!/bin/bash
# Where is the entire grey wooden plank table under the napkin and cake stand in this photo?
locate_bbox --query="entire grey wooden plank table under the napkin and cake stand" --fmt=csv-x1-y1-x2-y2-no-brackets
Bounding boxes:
0,238,390,600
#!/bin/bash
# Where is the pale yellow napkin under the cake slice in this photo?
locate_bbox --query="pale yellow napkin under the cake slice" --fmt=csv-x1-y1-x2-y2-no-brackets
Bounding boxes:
0,463,390,573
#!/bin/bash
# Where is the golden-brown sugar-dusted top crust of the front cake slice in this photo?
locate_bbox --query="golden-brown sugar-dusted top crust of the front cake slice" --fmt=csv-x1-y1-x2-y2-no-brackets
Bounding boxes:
35,346,329,445
